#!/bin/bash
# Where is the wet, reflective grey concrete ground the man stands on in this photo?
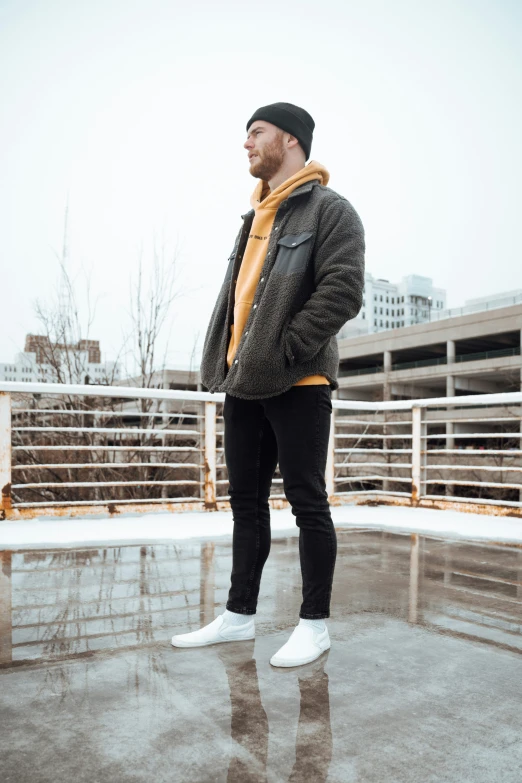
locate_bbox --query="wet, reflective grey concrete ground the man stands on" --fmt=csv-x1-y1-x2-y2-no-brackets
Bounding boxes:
0,530,522,783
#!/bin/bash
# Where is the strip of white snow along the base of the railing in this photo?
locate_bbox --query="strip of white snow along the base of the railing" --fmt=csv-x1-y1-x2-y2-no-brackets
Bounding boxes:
0,505,522,549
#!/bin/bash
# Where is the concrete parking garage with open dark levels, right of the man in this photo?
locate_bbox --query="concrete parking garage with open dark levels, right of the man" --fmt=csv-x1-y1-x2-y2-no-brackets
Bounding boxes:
337,303,522,400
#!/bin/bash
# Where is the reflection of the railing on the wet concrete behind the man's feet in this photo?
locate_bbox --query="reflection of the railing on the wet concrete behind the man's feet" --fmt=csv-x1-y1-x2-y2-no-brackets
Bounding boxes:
0,531,522,667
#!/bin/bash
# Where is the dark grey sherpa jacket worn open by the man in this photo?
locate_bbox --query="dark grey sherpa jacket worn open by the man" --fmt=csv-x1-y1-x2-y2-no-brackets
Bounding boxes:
200,180,365,400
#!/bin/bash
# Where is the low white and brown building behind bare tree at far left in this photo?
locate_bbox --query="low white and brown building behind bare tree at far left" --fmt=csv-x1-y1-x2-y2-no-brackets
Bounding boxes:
0,334,120,384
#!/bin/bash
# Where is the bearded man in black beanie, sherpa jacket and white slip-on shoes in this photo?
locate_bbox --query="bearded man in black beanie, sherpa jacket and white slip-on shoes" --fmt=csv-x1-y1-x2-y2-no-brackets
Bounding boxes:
172,103,365,666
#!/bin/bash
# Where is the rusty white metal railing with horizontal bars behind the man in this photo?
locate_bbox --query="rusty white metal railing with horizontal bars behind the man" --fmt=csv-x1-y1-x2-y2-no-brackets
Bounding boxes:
0,382,522,518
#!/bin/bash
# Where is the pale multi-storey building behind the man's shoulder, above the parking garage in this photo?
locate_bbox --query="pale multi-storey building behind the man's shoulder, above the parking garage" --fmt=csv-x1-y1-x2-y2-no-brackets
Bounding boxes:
339,272,446,339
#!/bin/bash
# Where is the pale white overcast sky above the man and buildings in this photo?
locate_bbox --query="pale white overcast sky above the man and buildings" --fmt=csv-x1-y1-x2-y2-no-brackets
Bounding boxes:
0,0,522,367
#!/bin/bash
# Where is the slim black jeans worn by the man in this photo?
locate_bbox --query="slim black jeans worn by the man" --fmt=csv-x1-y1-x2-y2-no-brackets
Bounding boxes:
223,384,337,620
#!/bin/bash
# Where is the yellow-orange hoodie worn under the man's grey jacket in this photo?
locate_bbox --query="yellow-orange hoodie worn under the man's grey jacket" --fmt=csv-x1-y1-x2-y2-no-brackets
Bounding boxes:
227,160,330,386
